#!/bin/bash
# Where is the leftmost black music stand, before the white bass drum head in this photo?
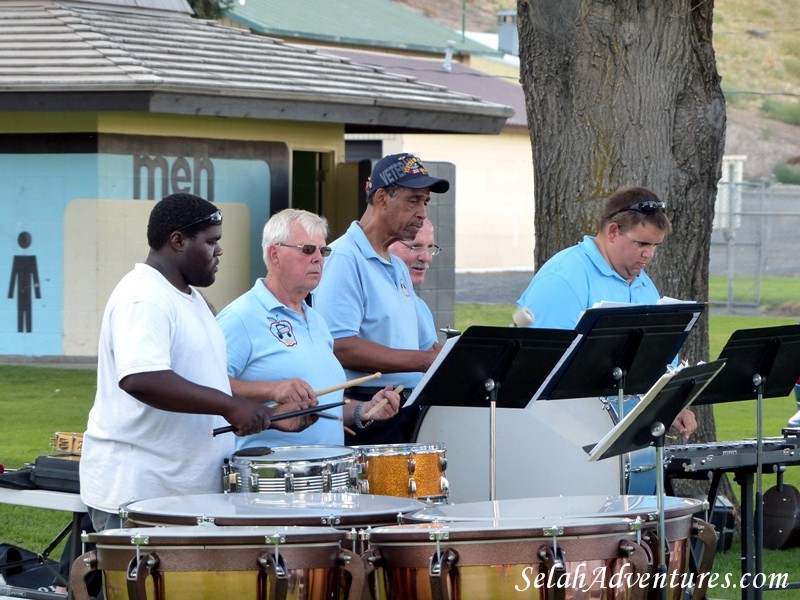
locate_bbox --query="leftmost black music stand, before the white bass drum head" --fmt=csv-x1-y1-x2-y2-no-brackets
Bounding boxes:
409,326,576,500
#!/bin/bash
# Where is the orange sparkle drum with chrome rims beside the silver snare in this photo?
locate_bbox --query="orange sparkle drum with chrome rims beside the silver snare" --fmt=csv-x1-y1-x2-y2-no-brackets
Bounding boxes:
353,443,449,502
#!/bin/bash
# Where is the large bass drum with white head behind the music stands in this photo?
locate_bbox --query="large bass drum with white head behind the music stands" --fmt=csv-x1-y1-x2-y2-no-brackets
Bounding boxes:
414,398,655,503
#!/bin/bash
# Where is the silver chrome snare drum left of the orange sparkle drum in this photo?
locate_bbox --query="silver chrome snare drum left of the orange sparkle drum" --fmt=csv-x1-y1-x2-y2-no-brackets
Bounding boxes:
223,446,356,493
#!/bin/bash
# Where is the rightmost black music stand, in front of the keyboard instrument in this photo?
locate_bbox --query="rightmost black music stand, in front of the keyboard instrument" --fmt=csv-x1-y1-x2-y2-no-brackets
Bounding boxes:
695,325,800,598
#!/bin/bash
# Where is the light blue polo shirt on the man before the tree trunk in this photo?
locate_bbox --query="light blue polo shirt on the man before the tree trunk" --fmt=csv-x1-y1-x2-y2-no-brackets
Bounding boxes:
517,235,660,329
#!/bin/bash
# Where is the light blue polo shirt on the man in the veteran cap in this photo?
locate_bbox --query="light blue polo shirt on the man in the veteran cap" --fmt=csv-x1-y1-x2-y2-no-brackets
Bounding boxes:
314,221,430,389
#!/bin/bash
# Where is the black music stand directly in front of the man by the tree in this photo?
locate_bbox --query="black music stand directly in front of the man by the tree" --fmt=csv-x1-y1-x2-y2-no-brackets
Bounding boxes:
533,302,706,494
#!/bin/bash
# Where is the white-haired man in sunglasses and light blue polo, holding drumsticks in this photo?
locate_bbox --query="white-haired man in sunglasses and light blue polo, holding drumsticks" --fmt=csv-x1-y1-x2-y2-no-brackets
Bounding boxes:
217,209,400,449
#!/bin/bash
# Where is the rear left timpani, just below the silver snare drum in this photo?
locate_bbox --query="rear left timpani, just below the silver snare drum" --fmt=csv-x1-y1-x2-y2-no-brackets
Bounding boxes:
120,492,425,529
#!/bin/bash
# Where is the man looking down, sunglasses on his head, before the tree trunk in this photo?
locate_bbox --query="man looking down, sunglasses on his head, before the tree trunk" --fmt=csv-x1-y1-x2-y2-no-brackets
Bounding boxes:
517,187,697,437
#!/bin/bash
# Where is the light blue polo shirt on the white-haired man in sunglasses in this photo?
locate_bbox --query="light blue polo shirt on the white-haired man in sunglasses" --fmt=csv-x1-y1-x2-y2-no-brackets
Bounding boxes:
217,279,346,449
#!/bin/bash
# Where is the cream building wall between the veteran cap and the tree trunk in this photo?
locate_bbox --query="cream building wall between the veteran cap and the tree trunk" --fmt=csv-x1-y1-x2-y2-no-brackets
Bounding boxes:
384,131,534,271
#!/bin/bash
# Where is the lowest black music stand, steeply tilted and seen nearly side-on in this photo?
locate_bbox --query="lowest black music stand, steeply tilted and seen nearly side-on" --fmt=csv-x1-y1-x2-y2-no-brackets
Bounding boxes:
584,360,725,599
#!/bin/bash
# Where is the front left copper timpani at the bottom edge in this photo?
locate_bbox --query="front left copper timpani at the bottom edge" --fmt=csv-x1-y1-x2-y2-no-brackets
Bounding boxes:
71,526,364,600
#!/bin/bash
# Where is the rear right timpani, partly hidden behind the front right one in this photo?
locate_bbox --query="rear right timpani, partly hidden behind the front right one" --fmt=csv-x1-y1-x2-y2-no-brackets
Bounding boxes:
404,495,716,599
